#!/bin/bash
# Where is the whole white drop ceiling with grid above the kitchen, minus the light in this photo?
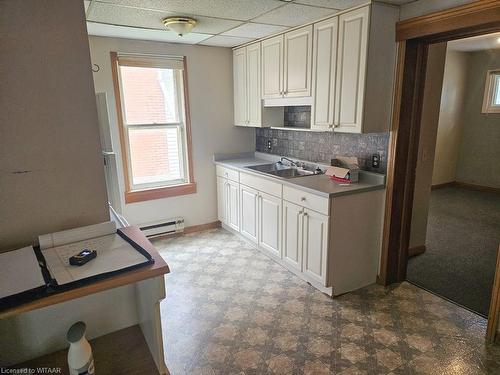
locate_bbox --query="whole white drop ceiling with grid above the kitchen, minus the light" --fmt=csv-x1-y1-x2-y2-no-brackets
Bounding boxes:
84,0,412,47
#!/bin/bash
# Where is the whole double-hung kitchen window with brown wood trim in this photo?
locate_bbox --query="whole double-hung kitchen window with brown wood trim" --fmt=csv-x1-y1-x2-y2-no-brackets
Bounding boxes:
111,52,196,203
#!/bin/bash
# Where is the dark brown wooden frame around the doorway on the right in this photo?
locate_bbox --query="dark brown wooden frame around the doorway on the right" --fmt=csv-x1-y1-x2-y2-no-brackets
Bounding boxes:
379,0,500,340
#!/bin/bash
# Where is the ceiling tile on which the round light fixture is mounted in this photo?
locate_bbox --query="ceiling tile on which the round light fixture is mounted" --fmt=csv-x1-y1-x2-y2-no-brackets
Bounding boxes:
87,2,242,34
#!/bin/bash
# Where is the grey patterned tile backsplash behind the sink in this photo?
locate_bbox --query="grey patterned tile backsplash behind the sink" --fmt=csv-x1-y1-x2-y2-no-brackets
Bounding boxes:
255,127,389,173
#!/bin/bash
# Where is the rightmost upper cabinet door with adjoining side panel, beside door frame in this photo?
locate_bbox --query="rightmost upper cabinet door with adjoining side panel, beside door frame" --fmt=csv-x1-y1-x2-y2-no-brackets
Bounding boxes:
333,2,399,133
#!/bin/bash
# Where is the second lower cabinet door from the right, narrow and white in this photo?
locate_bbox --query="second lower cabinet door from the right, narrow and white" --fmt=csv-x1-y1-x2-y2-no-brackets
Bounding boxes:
282,201,304,271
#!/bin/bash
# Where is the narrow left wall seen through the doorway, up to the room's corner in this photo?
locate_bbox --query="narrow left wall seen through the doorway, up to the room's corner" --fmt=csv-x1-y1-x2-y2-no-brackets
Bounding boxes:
432,51,469,185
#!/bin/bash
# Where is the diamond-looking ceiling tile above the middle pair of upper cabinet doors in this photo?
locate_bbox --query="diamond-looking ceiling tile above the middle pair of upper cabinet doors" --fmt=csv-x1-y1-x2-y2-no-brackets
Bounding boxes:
252,3,337,26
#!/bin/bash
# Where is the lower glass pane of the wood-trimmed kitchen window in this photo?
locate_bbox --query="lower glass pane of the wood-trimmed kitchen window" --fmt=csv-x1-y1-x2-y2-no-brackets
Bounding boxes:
127,126,187,190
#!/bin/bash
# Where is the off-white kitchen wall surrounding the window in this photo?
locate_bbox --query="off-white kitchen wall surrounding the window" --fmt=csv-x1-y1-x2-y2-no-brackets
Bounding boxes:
89,36,255,226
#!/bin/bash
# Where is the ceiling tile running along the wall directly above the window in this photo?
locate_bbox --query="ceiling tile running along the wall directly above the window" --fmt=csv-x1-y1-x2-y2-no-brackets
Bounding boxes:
87,22,212,44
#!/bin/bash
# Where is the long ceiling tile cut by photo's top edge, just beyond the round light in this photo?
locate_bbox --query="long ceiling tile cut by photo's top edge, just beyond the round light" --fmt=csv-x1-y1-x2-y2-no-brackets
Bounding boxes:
94,0,283,21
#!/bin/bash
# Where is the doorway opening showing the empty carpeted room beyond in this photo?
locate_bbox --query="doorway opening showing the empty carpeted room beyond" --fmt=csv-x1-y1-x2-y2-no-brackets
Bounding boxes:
407,33,500,317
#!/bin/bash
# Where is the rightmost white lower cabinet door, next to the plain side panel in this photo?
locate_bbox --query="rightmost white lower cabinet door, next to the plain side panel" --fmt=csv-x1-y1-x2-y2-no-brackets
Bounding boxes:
302,209,328,286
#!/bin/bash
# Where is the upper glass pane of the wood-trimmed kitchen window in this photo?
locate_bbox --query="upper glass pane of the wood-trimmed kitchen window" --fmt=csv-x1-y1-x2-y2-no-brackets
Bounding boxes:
119,66,181,125
